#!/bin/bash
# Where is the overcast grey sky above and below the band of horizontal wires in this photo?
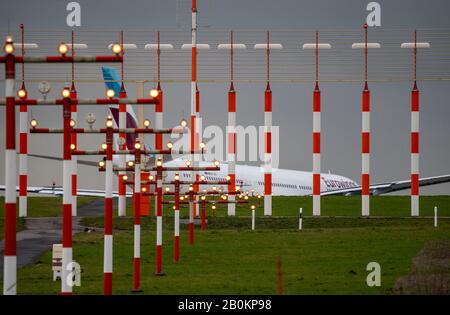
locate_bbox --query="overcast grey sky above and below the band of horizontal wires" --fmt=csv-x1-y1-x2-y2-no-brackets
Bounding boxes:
0,0,450,194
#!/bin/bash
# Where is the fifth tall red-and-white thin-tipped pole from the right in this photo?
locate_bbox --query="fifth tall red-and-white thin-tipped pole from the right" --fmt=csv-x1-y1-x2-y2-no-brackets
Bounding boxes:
228,31,236,216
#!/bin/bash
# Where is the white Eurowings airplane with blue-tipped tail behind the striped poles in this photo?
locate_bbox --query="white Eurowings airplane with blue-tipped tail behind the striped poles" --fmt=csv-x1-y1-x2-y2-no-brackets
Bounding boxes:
0,67,450,197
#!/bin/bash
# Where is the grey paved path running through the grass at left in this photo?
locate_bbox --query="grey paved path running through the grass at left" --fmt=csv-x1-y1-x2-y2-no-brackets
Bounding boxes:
0,199,104,277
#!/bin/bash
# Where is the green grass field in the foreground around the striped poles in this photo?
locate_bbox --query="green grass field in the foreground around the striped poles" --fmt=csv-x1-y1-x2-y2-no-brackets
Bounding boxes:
0,196,450,294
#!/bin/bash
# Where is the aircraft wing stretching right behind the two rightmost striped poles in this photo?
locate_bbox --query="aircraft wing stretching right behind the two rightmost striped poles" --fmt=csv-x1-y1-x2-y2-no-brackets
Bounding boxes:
321,175,450,196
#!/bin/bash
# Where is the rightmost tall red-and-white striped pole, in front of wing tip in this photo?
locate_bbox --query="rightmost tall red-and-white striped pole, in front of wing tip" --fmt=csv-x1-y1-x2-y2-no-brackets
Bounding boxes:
411,31,420,217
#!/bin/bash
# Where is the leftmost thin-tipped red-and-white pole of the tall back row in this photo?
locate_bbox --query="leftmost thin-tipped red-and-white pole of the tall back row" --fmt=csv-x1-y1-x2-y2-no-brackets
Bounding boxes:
19,24,28,217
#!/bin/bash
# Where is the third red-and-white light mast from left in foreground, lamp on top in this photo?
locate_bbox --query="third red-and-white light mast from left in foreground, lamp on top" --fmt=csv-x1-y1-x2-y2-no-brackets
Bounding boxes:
103,117,114,295
